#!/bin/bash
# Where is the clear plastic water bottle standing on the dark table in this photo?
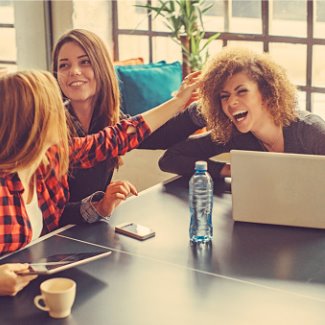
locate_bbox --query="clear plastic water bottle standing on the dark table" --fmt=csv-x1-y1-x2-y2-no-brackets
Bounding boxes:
189,161,213,243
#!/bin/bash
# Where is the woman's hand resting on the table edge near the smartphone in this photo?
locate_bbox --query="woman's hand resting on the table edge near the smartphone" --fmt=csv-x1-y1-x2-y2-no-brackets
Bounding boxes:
95,181,138,216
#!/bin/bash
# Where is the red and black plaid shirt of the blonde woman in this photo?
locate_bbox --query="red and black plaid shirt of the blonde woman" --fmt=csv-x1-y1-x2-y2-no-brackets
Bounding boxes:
0,115,150,254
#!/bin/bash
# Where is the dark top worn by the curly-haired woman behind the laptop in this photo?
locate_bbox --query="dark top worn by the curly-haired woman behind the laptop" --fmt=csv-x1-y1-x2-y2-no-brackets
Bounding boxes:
159,111,325,178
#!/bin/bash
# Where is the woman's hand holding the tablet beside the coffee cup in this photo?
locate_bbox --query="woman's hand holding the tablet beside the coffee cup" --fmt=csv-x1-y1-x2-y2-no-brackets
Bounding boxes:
0,264,37,296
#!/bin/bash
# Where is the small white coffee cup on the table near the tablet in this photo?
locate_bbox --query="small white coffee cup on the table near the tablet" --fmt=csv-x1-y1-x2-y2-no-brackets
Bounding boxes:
34,278,77,318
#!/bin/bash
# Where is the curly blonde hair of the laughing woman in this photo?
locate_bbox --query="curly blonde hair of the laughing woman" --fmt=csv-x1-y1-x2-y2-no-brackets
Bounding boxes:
200,47,297,143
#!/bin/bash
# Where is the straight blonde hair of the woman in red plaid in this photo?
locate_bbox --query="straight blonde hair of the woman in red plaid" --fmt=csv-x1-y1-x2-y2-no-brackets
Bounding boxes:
0,71,69,176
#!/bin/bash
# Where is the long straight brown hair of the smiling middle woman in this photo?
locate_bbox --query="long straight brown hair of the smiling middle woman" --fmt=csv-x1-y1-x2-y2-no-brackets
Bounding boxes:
52,29,120,128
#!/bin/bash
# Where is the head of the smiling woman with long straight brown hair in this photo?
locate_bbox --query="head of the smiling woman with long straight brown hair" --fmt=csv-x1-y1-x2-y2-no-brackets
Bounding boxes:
52,29,120,136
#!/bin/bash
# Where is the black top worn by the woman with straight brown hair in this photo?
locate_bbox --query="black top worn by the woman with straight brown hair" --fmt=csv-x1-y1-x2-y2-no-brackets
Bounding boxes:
60,105,205,226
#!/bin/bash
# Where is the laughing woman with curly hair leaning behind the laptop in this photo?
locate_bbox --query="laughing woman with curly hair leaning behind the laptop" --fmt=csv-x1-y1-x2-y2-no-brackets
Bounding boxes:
159,47,325,178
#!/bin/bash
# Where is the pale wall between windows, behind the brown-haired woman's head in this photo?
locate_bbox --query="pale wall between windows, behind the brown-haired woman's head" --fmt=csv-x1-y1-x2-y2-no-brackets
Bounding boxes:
13,0,113,70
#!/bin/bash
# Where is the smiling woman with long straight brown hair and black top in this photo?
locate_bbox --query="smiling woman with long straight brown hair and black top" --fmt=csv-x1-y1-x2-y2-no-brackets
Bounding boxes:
52,29,204,224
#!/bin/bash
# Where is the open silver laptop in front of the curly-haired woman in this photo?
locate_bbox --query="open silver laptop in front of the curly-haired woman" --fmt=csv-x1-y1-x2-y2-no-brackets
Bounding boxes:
230,150,325,228
